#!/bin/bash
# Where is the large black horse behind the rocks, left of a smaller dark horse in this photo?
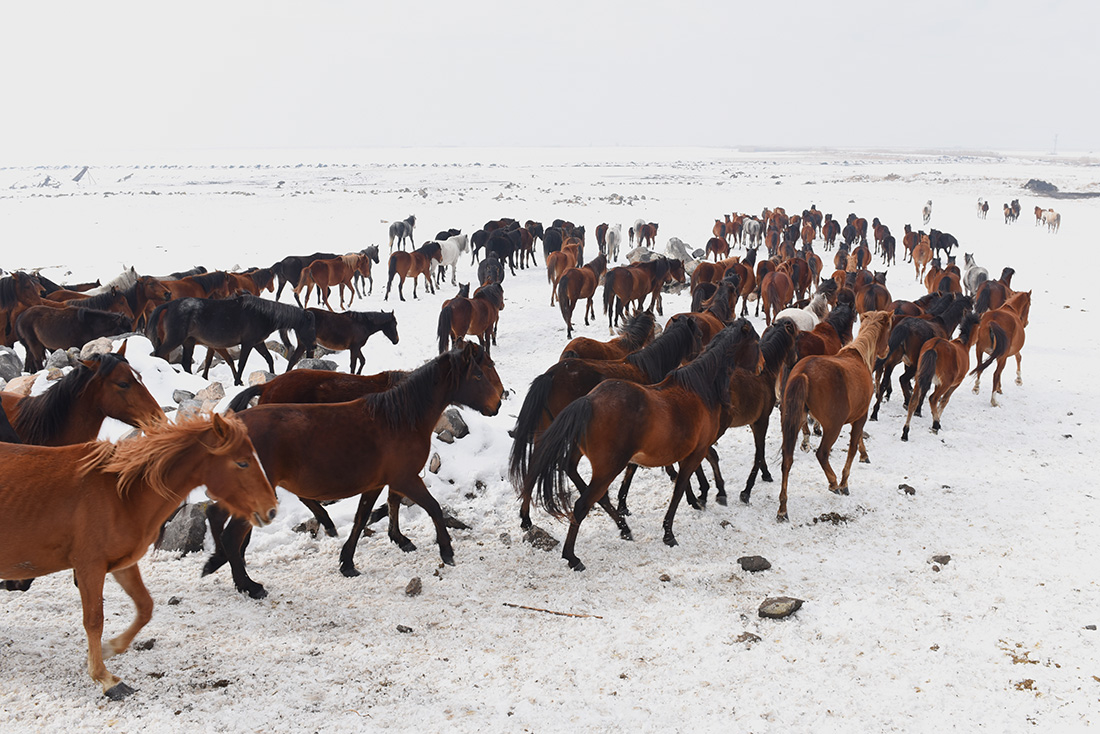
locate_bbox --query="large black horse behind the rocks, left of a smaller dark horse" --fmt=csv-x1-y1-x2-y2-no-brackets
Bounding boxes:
145,295,317,385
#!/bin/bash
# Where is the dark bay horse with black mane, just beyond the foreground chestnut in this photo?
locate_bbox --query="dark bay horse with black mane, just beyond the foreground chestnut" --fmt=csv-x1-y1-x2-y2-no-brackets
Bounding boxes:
202,342,504,599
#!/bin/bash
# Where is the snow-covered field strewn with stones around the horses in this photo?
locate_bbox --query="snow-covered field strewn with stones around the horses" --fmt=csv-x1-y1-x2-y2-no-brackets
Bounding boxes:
0,149,1100,732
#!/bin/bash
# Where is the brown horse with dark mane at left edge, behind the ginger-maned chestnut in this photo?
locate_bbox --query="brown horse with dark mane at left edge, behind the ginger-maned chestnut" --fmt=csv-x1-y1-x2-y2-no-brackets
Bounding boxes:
0,343,164,446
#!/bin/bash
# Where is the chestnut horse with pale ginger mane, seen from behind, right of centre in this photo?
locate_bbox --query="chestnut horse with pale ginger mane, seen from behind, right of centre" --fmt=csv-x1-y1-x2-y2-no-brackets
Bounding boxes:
776,311,890,521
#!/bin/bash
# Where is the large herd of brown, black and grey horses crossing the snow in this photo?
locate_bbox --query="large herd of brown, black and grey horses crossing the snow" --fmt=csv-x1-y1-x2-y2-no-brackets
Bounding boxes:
0,196,1031,699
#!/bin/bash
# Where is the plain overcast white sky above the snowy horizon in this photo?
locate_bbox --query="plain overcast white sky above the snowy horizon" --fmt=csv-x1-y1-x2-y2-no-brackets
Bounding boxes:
0,0,1100,159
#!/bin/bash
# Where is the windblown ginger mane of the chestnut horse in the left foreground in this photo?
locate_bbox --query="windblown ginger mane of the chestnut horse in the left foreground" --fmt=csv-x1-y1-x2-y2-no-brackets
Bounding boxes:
80,415,249,497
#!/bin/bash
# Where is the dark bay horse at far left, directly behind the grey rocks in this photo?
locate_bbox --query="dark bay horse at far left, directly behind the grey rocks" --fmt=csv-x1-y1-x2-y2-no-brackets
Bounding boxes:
15,305,133,372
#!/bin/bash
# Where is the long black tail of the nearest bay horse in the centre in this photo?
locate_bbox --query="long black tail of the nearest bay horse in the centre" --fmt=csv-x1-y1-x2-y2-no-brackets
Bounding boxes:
524,396,592,517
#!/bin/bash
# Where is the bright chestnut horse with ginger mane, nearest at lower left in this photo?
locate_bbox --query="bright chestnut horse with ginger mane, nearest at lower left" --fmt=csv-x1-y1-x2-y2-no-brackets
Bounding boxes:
0,415,276,700
